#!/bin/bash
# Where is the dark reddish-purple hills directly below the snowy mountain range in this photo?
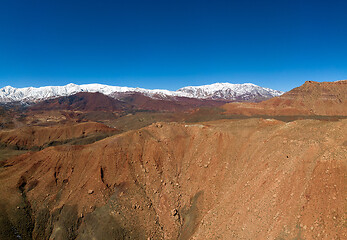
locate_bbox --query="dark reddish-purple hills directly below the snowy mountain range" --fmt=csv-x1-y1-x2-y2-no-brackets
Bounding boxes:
28,92,230,112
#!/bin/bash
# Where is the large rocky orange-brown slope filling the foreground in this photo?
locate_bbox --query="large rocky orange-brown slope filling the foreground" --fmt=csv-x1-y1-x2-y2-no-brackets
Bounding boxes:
0,119,347,239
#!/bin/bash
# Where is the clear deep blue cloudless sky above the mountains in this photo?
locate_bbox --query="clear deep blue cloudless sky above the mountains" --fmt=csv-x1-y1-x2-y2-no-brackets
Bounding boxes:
0,0,347,90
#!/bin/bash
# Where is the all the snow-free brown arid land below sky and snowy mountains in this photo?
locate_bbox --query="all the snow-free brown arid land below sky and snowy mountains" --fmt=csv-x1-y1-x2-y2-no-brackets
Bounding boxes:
0,81,347,240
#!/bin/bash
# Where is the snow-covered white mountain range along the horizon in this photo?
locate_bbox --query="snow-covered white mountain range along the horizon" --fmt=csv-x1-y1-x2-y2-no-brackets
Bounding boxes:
0,83,283,103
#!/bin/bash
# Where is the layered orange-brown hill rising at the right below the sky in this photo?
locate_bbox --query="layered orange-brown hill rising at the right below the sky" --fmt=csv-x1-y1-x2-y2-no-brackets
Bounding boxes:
223,80,347,116
